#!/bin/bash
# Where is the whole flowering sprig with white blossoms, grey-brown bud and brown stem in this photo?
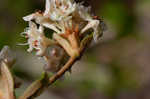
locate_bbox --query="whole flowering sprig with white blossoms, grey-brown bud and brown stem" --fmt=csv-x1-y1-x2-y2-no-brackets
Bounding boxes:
0,0,104,99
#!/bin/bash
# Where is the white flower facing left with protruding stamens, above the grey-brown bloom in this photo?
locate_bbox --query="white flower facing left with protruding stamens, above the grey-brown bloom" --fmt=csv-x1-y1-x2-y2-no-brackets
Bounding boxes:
23,21,52,56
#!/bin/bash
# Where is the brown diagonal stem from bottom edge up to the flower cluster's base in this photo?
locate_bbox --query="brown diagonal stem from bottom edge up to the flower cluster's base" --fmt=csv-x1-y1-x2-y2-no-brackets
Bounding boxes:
22,57,77,99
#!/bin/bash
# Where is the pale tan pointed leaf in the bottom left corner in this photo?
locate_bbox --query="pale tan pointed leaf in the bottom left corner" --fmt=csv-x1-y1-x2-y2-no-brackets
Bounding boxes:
0,61,15,99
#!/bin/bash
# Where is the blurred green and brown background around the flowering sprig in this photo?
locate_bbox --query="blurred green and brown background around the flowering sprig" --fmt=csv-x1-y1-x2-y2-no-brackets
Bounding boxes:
0,0,150,99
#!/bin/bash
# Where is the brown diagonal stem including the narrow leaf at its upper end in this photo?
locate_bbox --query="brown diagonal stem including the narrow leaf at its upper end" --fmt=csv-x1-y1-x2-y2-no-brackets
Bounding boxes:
19,35,93,99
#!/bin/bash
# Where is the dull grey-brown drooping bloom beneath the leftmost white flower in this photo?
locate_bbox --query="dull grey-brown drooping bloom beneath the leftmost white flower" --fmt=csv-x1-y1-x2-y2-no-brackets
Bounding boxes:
44,45,68,73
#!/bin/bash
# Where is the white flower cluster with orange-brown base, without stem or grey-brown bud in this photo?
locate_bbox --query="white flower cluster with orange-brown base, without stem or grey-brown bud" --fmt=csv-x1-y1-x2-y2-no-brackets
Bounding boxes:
23,0,103,72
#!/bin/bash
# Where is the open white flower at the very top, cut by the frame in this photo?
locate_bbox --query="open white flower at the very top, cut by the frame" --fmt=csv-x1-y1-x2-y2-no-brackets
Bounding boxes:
44,0,76,21
